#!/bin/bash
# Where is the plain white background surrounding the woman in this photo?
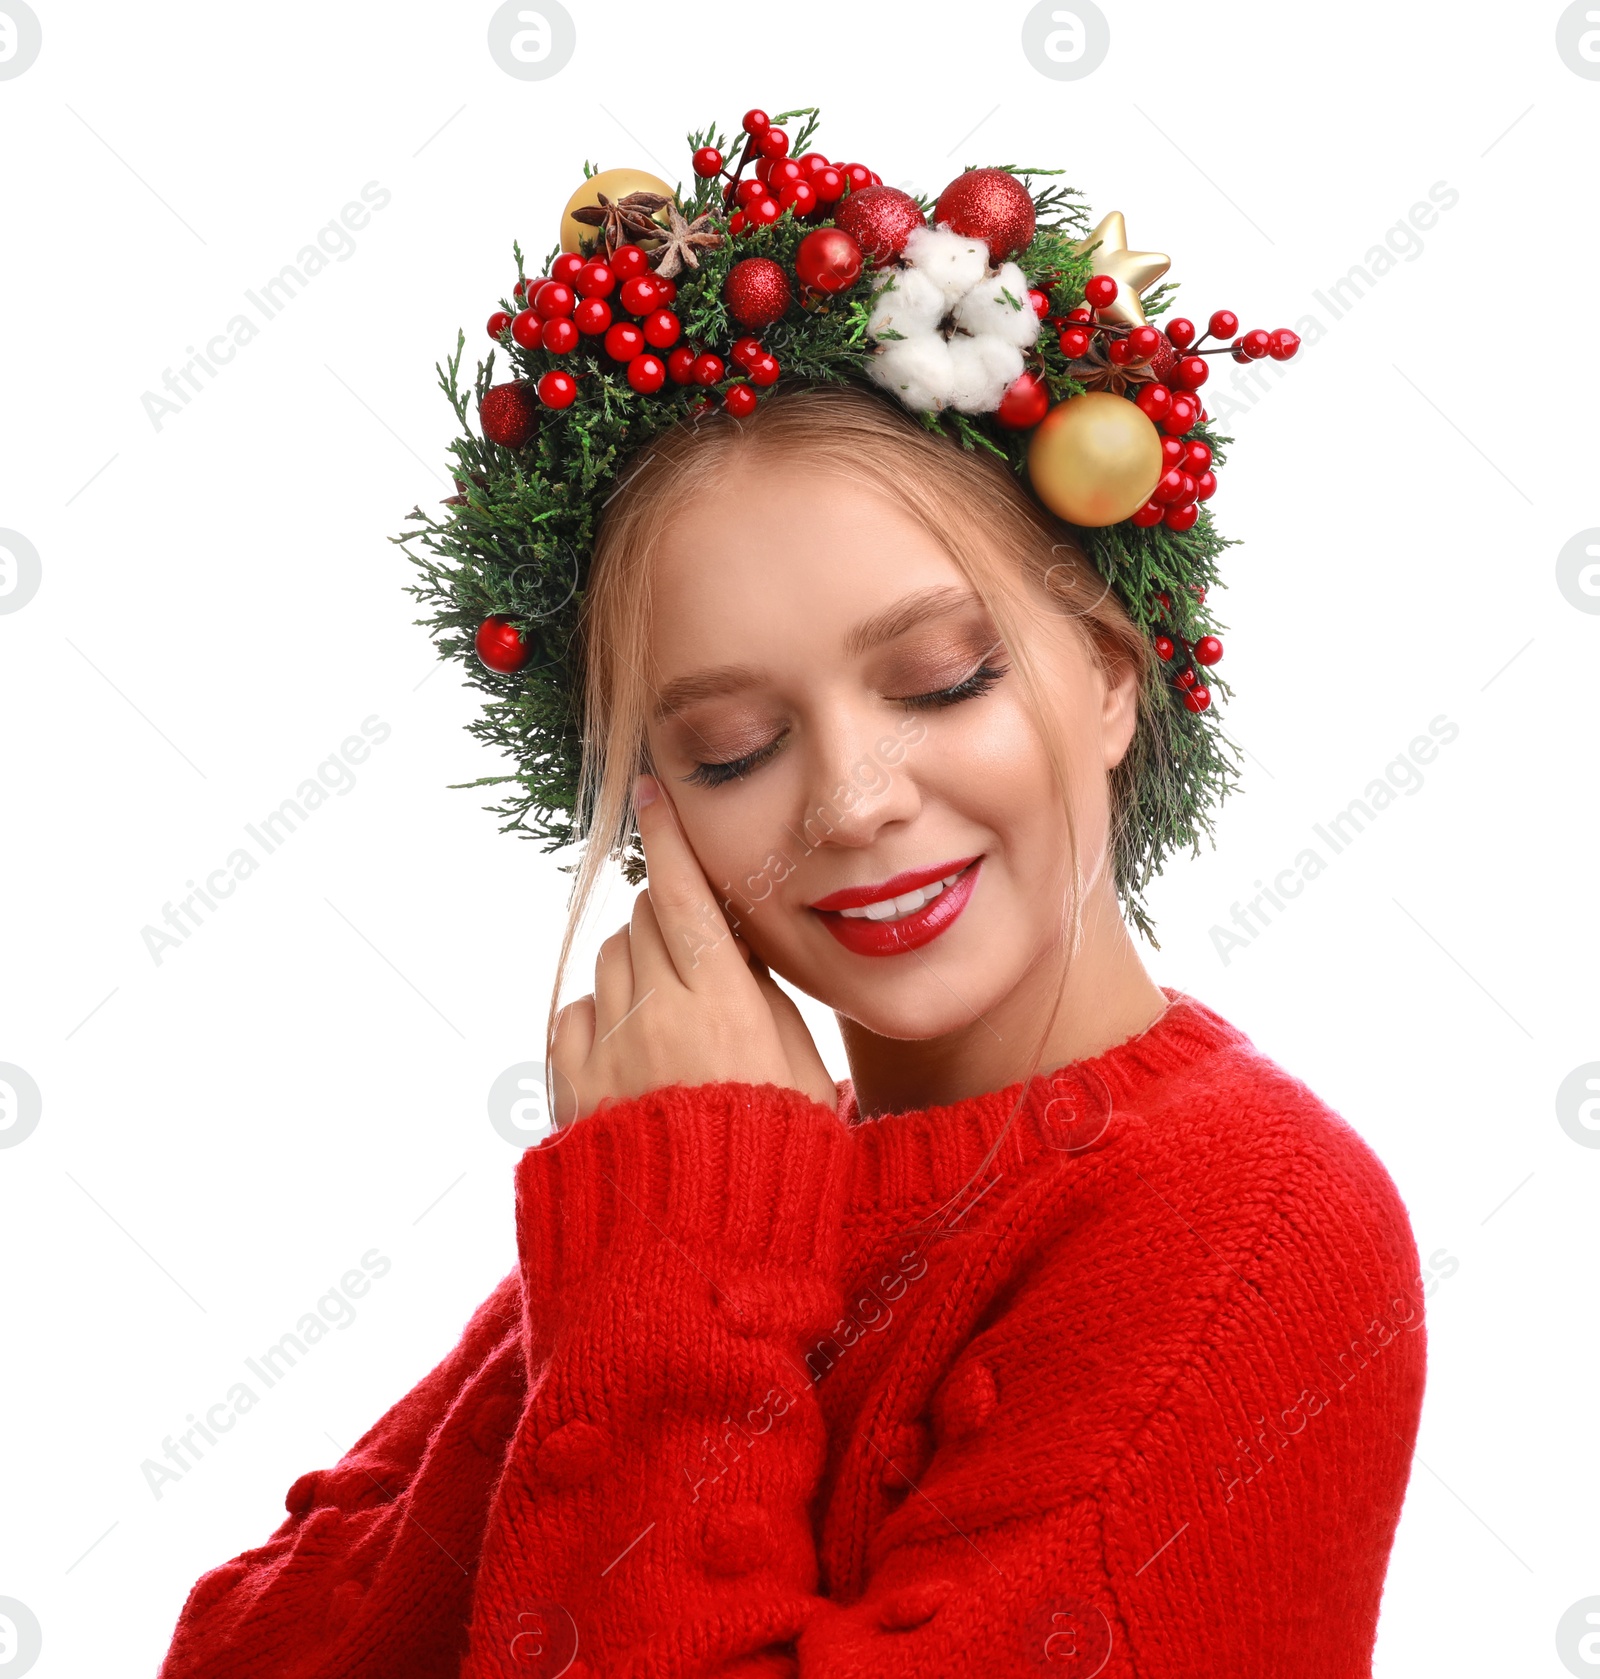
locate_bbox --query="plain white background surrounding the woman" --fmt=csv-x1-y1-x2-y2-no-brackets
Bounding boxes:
0,0,1600,1679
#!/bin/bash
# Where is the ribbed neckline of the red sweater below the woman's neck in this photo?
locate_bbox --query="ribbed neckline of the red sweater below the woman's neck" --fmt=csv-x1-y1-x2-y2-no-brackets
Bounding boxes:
839,986,1249,1206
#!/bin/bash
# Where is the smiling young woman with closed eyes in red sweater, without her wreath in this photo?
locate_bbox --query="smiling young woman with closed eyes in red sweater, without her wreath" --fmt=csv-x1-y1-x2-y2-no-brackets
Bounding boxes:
152,112,1424,1679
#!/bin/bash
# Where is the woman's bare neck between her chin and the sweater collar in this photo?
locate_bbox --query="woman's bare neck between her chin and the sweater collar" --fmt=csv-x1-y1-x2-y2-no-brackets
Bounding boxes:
839,876,1167,1118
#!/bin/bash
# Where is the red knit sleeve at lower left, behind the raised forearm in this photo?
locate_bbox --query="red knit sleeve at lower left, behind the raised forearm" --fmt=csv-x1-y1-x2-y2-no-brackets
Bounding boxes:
159,1271,524,1679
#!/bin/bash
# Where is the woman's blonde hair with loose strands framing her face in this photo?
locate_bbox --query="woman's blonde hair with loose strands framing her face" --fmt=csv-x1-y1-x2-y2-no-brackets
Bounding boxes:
549,384,1152,1114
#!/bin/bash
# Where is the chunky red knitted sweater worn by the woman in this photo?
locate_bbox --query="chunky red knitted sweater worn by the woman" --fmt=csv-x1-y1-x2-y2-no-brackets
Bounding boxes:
152,991,1425,1679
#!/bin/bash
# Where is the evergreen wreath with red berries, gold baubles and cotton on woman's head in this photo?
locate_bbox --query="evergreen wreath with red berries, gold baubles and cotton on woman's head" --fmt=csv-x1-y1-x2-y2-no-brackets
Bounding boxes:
395,109,1299,935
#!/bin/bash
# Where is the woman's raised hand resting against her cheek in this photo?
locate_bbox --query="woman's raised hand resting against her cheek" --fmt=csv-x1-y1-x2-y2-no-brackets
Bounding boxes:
551,776,836,1125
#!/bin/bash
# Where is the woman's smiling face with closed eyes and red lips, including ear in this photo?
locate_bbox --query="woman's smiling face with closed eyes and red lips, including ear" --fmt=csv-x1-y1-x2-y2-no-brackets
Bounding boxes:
648,462,1135,1039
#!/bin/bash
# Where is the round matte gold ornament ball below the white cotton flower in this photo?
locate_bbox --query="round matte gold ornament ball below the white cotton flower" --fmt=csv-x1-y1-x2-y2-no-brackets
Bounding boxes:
1027,391,1162,526
